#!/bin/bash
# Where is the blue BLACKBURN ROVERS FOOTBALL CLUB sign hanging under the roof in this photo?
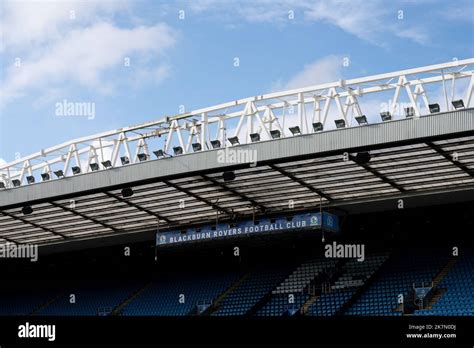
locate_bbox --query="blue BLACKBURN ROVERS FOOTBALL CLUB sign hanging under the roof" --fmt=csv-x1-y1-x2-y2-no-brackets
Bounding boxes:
156,212,339,246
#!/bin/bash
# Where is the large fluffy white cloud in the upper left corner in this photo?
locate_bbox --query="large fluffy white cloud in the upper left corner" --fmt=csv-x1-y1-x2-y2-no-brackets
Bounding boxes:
2,1,177,106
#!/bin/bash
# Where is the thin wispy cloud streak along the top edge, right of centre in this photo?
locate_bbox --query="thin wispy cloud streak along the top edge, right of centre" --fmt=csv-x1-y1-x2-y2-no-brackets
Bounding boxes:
183,0,436,46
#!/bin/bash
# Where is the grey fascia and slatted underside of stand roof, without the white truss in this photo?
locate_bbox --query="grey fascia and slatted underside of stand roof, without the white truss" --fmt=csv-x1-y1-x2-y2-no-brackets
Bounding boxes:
0,109,474,244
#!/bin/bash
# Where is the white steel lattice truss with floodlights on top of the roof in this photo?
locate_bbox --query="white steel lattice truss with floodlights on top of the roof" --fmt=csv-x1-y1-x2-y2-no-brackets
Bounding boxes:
0,58,474,188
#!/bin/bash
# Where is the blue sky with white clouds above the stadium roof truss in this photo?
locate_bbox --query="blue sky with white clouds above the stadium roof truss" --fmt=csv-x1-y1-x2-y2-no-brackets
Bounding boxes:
0,0,474,162
